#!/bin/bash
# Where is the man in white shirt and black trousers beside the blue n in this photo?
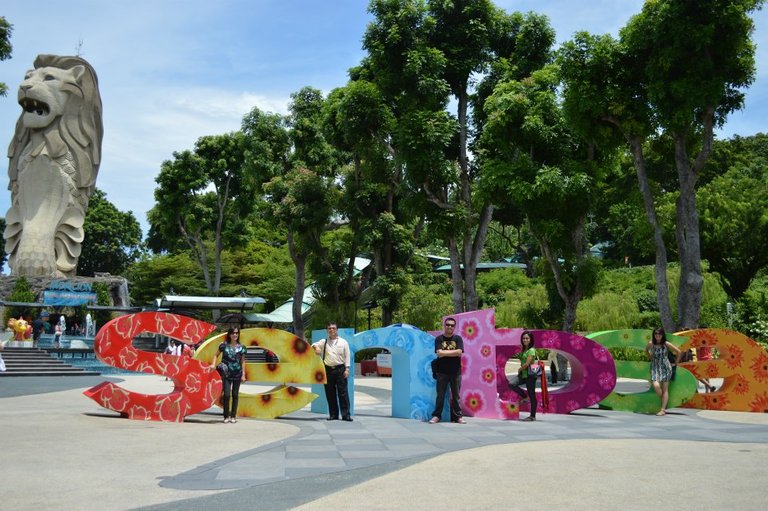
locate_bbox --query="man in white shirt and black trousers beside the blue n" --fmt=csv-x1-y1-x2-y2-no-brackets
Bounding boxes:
312,322,352,422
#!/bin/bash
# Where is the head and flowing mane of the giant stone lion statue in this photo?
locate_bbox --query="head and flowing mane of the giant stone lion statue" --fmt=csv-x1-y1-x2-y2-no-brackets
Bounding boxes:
8,55,104,195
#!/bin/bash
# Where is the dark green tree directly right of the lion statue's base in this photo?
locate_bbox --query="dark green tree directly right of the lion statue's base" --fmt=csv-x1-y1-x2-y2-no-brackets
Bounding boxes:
77,188,142,276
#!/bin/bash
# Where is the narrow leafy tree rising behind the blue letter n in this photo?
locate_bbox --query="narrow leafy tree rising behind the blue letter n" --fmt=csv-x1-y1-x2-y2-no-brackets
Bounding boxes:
326,79,421,325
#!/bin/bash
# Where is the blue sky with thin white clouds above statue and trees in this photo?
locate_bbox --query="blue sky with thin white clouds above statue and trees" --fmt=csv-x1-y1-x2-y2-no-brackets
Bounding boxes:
0,0,768,235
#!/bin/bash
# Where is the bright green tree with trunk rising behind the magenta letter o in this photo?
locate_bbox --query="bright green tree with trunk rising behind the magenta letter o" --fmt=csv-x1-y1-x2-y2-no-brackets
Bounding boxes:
480,65,611,331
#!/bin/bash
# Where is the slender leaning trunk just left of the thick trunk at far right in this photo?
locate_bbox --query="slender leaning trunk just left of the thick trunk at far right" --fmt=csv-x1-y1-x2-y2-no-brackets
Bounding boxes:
627,137,675,332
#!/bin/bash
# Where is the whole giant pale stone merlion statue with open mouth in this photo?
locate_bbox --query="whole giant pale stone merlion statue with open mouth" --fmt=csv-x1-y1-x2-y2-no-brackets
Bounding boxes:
4,55,104,277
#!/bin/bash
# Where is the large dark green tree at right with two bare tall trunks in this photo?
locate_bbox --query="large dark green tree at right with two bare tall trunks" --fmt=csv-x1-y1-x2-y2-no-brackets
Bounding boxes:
561,0,763,329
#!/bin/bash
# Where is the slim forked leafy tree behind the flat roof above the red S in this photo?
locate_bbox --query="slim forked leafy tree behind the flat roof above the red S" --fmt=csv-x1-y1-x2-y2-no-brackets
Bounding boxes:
148,132,254,296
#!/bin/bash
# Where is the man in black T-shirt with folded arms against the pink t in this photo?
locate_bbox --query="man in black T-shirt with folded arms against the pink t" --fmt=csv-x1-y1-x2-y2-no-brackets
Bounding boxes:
429,318,466,424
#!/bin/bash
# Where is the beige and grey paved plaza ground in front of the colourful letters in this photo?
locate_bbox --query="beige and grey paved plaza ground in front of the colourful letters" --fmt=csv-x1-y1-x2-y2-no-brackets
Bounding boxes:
0,375,768,511
